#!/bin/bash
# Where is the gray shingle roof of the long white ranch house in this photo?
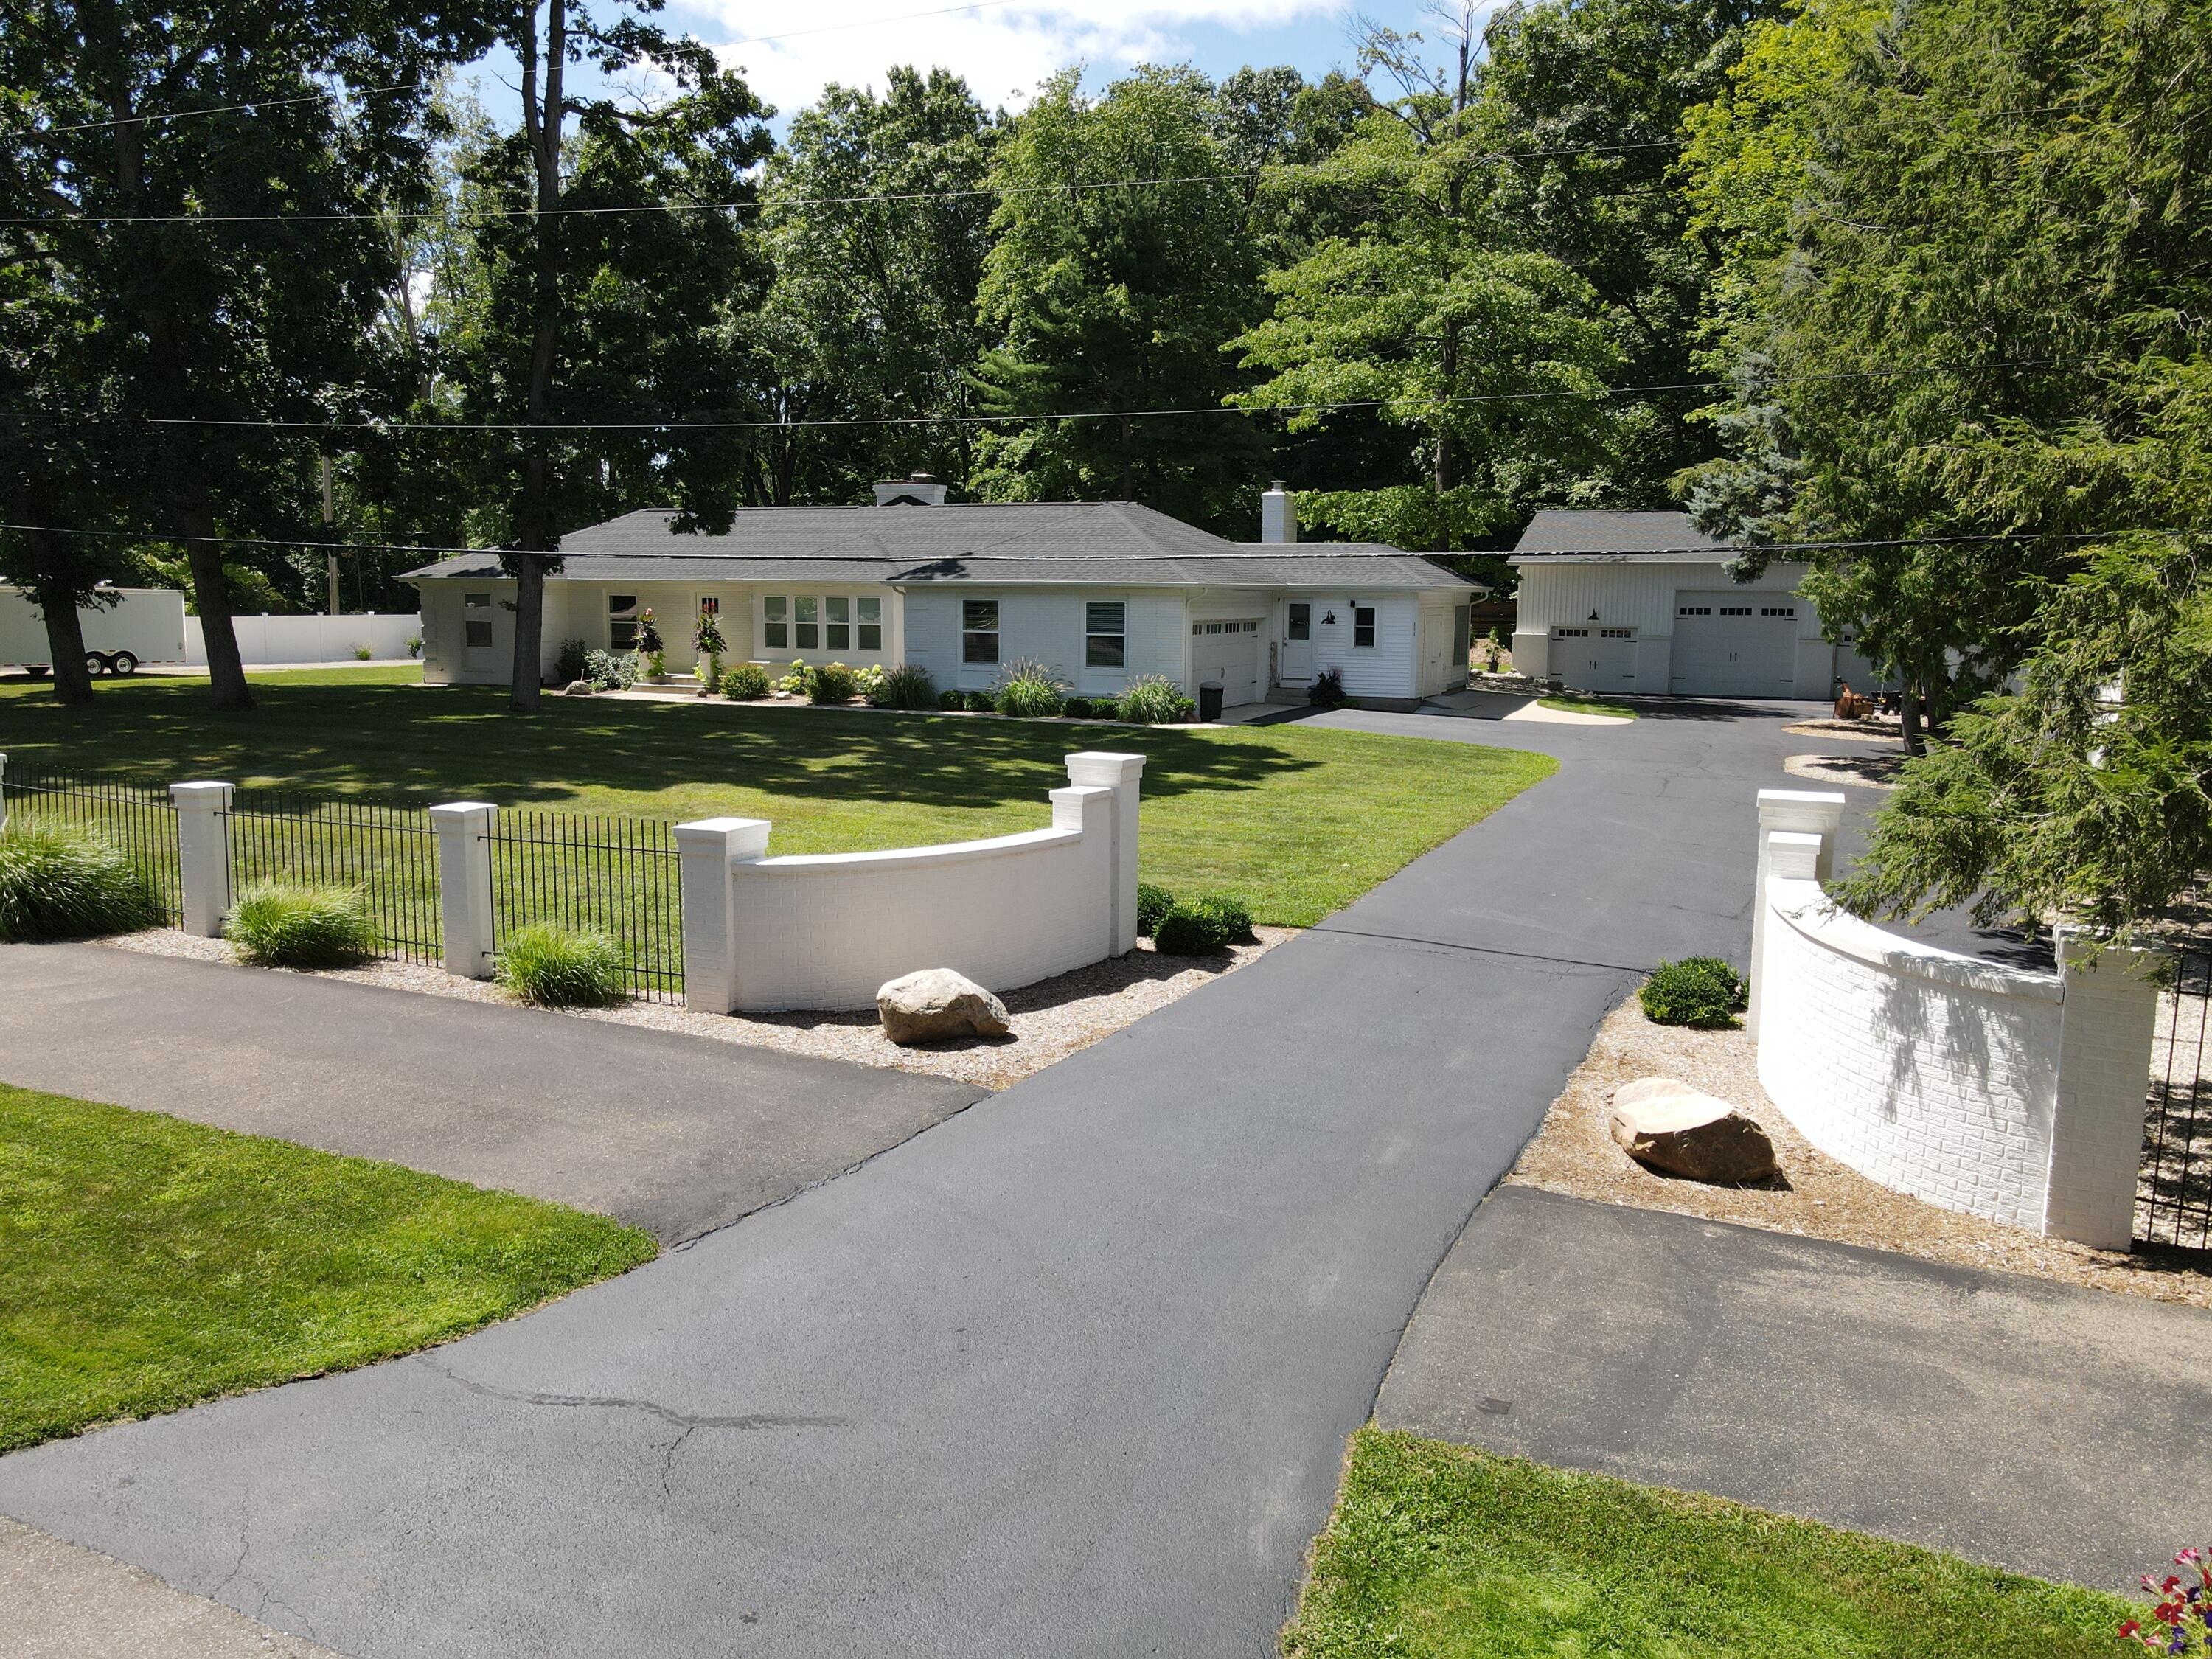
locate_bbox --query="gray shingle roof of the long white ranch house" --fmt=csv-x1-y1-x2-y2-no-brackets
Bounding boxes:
407,502,1467,588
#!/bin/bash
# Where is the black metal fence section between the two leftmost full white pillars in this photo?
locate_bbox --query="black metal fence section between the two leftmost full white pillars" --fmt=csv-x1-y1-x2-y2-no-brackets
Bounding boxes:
230,790,445,964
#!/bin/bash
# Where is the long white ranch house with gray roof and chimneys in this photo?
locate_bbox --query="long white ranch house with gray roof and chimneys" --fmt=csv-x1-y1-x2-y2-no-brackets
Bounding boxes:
407,480,1473,706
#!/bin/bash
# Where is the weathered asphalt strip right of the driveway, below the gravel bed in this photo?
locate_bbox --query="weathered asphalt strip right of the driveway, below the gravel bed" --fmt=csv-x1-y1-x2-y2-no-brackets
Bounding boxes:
1376,1186,2212,1593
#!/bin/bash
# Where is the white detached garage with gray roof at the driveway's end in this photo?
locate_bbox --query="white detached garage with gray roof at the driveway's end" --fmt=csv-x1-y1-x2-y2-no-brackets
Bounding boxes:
1513,513,1865,701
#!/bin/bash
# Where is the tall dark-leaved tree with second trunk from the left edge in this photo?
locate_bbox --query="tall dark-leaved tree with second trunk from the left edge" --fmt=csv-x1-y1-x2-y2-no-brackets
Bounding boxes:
0,0,491,708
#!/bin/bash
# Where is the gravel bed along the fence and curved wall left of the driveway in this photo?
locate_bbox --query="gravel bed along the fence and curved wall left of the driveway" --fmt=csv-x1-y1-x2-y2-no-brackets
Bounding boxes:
95,927,1298,1088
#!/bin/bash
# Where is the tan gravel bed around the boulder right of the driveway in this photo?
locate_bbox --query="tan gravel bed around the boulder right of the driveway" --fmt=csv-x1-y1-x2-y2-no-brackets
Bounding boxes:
1506,995,2212,1307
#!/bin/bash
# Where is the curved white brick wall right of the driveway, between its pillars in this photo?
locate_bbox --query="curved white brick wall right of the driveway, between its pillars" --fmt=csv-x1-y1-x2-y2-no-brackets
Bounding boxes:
1759,876,2064,1232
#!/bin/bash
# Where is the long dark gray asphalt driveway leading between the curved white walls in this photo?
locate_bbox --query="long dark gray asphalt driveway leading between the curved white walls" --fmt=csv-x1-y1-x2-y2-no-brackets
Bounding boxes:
0,703,1885,1659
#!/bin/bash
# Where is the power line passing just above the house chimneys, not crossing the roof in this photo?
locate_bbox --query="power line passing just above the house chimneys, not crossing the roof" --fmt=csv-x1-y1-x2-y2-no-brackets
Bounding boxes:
0,358,2079,434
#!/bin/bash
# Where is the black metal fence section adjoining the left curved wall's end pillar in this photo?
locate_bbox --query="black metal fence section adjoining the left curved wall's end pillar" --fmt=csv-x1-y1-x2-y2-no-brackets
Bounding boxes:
491,807,684,1002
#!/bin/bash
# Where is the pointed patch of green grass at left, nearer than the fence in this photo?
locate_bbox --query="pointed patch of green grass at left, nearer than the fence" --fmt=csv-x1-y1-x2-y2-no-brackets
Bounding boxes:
0,1084,655,1451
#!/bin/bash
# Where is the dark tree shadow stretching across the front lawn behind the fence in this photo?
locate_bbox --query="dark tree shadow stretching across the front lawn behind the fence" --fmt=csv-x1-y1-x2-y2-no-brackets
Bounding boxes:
0,681,1321,807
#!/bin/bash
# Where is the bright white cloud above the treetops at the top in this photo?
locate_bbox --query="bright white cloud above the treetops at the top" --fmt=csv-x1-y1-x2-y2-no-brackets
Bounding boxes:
692,0,1343,115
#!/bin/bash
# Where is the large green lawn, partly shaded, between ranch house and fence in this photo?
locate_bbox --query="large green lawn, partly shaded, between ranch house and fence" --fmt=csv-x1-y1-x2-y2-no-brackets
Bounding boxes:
0,668,1555,927
